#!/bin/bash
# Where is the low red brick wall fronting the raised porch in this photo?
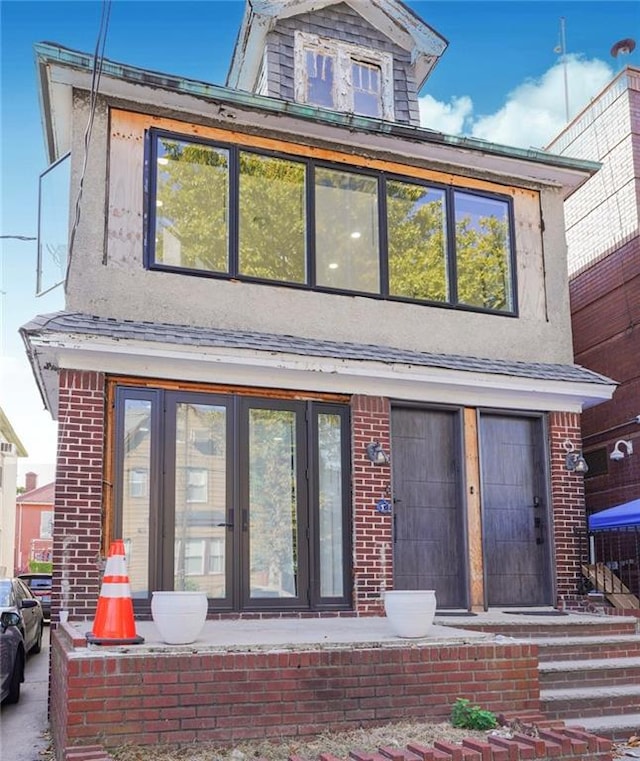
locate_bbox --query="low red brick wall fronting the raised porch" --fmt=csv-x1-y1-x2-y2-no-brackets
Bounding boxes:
51,626,539,749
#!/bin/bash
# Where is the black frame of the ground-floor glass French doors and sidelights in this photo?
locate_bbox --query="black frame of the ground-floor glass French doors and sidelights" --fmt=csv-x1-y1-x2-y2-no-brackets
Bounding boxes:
111,383,353,615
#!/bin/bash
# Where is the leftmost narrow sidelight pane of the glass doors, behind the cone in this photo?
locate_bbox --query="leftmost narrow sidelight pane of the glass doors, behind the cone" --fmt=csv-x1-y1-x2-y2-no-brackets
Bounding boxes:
122,399,151,598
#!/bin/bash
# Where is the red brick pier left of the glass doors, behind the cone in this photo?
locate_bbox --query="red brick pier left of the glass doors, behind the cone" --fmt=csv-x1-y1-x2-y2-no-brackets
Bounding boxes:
52,370,105,620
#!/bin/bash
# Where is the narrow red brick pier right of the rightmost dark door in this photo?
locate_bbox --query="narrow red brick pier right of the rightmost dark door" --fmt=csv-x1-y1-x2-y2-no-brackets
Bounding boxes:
549,412,587,607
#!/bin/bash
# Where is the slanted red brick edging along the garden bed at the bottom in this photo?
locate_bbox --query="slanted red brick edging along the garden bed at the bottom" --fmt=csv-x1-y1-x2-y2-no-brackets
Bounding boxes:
64,714,613,761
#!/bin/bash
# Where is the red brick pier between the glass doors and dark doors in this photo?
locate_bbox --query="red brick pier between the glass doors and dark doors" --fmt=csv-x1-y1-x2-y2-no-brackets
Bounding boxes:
351,396,393,615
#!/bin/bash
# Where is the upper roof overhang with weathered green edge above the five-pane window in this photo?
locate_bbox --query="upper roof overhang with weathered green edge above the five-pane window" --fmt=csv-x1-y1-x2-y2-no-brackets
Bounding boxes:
36,43,600,196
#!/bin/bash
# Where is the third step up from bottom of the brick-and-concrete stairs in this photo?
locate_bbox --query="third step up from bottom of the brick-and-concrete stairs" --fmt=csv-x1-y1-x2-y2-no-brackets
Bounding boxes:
538,657,640,690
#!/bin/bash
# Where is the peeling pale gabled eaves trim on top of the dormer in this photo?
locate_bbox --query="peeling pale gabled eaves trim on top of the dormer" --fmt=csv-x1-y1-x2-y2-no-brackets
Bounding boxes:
227,0,448,92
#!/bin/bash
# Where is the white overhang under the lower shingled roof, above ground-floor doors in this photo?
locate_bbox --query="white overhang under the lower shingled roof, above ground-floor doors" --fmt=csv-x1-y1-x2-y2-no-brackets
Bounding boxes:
22,320,616,419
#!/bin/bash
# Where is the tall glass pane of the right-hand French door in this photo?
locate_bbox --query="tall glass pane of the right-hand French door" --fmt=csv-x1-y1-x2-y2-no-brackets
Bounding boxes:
249,409,298,597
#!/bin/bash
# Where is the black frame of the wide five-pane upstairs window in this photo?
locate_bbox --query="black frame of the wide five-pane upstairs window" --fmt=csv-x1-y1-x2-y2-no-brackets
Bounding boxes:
143,127,518,317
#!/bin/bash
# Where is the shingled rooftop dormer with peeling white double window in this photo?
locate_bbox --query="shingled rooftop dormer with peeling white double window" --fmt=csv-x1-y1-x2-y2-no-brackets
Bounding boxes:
227,0,447,125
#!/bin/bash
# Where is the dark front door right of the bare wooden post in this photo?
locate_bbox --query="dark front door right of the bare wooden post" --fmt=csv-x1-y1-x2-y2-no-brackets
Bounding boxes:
480,414,553,606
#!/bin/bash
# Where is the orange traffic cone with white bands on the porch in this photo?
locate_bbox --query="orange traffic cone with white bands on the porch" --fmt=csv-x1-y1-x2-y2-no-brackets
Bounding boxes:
87,539,144,645
